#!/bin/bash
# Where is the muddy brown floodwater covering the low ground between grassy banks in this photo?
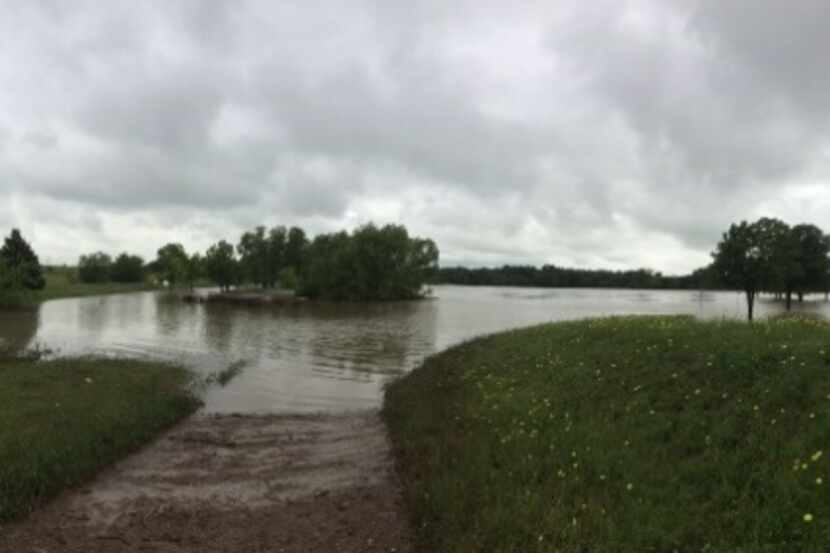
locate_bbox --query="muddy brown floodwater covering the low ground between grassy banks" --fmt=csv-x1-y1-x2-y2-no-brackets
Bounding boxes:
0,286,830,413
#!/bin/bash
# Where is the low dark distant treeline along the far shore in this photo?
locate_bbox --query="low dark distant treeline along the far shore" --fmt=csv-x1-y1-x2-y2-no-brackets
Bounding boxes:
435,265,716,289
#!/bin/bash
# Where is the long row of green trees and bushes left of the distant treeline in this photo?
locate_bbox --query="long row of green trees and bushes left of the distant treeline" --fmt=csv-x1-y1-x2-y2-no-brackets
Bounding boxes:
78,224,439,301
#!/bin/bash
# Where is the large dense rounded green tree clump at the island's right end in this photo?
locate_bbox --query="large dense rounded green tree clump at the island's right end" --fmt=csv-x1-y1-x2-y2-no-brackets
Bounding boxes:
300,224,438,301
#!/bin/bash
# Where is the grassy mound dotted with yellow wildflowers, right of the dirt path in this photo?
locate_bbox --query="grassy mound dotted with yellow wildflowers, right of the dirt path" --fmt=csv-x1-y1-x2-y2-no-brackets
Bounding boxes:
384,317,830,553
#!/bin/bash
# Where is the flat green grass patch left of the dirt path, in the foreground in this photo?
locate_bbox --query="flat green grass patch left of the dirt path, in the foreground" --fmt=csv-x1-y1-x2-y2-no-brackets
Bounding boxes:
0,359,198,521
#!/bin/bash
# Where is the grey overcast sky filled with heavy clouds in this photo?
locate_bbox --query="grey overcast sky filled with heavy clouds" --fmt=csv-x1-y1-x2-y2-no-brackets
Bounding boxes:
0,0,830,273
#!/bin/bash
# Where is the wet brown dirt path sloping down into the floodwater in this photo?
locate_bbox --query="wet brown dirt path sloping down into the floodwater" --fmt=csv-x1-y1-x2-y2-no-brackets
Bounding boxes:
0,413,410,553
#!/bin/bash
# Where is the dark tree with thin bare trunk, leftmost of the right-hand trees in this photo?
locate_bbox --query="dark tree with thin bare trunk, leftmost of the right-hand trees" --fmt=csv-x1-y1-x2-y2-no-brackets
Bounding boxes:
712,221,768,321
